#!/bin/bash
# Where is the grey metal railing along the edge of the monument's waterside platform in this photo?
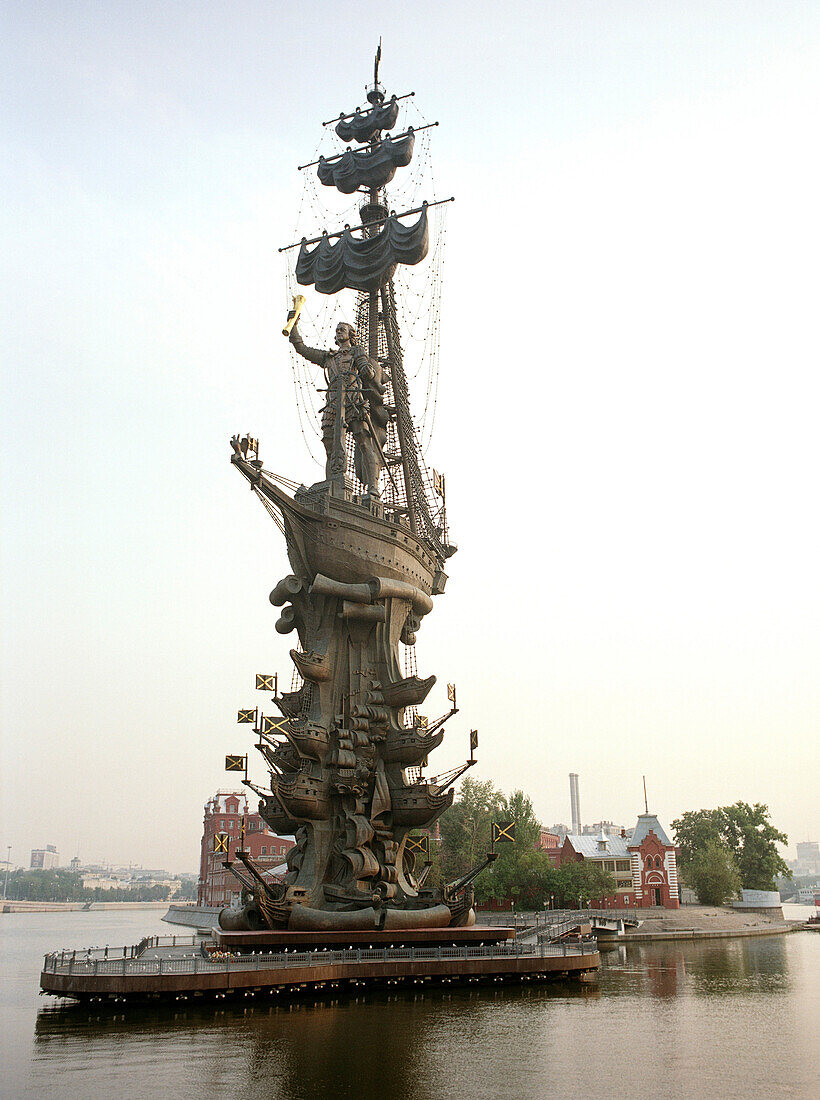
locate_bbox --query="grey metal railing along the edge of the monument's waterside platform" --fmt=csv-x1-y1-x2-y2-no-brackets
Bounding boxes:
43,936,598,977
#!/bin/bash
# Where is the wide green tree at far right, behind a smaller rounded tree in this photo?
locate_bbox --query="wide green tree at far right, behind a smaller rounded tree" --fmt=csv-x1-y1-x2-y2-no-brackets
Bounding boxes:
671,802,790,890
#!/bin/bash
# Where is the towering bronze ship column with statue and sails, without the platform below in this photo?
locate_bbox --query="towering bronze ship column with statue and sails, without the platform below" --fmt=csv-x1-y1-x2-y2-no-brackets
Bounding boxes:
228,51,474,931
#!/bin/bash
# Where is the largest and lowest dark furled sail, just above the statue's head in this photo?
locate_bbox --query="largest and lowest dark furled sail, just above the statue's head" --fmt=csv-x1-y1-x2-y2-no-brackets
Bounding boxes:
296,205,429,294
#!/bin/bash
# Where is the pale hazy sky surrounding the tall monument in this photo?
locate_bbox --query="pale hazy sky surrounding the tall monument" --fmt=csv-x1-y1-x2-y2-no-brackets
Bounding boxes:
0,0,820,870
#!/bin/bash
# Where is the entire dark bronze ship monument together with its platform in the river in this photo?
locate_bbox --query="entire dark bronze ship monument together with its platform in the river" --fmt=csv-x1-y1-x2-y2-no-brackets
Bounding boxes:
41,54,598,1011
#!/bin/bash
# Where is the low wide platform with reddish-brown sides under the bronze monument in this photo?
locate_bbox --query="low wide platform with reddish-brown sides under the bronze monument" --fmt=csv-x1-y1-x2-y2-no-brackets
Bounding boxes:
40,928,599,1004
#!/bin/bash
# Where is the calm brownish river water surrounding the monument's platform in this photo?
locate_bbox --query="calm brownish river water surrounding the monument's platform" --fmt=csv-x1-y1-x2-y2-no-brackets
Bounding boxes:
0,906,820,1100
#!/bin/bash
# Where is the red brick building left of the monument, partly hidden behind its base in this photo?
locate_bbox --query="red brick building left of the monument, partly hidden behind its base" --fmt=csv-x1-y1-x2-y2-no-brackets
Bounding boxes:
197,791,294,905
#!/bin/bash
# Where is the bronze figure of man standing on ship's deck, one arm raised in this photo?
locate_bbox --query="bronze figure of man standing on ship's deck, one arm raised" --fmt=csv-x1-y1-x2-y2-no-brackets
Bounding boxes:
289,321,389,501
